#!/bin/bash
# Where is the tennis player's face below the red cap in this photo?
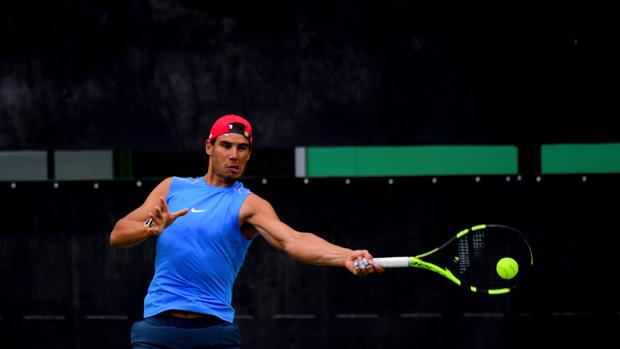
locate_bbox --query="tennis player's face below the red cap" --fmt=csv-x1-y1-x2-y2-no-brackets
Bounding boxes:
206,133,252,183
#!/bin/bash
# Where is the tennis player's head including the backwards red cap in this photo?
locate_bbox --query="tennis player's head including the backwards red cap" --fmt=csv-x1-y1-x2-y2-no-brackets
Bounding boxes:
205,114,252,185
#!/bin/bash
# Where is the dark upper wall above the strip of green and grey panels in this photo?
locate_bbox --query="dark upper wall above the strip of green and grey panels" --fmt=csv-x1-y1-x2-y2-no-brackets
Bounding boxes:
0,0,620,150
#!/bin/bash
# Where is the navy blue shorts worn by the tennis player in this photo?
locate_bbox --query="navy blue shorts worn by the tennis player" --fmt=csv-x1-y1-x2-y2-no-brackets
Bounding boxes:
131,314,241,349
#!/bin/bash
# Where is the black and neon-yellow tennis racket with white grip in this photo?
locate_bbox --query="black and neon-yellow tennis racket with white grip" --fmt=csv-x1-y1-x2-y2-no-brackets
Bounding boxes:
374,224,534,295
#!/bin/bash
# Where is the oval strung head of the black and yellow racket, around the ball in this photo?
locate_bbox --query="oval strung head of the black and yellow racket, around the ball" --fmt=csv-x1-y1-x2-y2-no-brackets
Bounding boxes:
428,224,534,294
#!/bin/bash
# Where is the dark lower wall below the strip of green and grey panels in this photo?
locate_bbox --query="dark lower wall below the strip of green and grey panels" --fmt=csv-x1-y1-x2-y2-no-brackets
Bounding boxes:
0,175,620,348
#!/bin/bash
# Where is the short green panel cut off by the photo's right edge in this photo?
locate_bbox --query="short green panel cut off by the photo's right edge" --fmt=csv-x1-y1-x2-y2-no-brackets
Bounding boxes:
541,143,620,174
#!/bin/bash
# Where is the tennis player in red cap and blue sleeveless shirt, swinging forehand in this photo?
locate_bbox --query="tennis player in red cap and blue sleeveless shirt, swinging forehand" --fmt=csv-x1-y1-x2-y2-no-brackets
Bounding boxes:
110,114,383,348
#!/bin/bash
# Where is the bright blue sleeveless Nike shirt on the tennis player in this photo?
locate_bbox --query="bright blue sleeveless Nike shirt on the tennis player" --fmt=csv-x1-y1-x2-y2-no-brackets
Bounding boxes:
144,177,252,322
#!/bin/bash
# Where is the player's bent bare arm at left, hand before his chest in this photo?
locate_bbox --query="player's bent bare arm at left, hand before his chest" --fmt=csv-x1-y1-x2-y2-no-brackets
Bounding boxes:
110,178,187,247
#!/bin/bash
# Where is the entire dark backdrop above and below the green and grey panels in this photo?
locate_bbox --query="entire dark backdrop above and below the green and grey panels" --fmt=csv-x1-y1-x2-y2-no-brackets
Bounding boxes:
0,0,620,348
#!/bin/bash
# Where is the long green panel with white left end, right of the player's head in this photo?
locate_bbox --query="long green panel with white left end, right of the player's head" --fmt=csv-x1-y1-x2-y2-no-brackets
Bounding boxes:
307,146,518,177
